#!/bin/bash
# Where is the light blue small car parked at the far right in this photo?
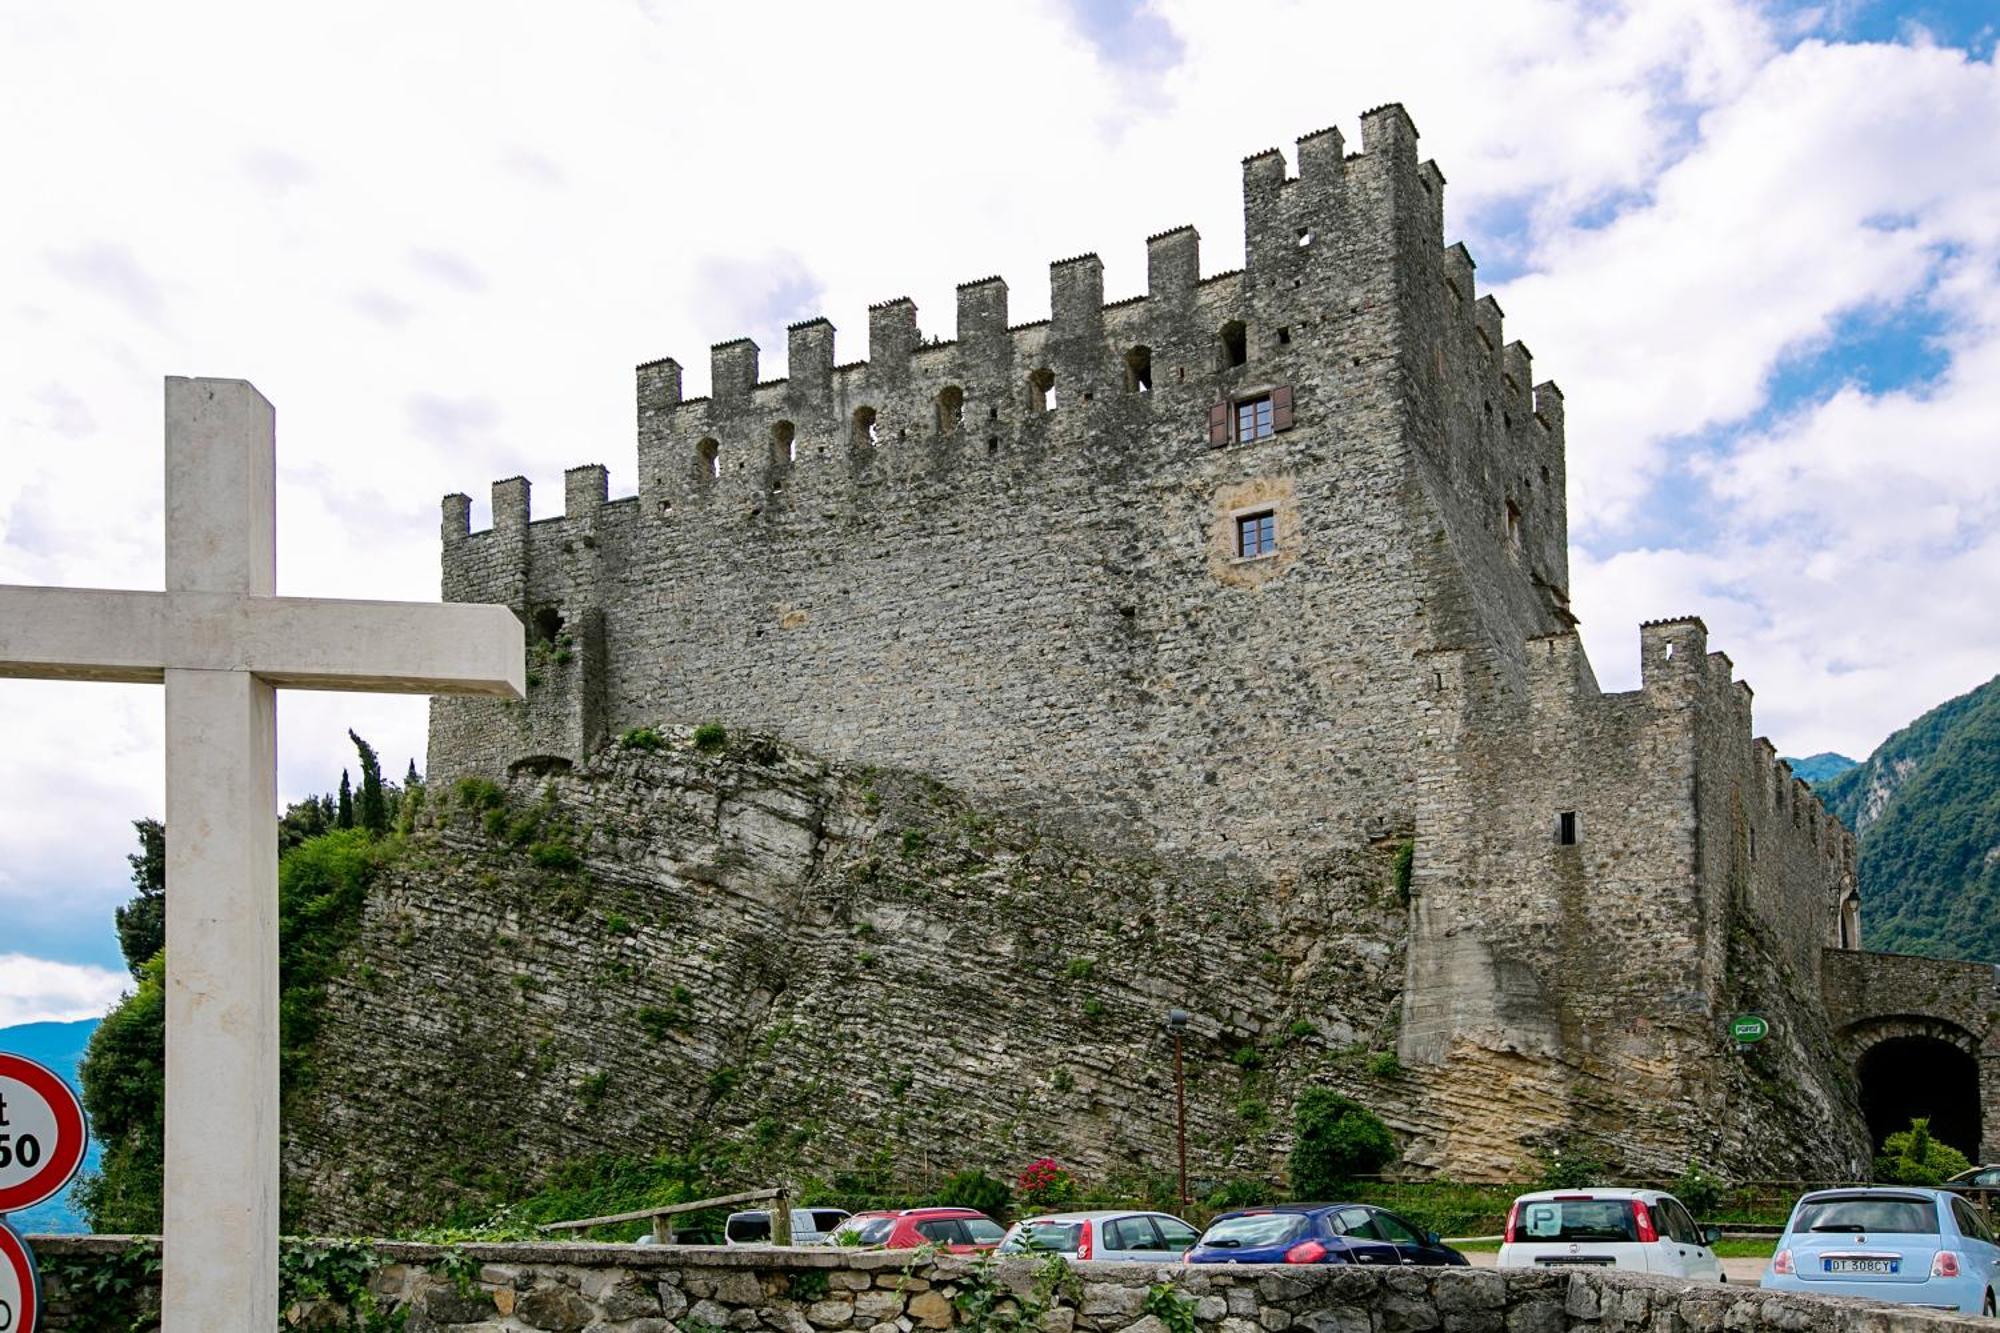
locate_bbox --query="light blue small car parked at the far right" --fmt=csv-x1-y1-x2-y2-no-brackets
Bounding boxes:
1758,1187,2000,1315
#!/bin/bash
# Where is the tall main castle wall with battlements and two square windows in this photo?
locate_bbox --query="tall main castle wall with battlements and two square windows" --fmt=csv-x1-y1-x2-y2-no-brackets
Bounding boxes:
432,108,1562,865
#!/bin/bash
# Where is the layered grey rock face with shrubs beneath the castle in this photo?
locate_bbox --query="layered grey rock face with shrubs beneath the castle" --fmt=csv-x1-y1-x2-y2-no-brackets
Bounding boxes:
286,733,1436,1231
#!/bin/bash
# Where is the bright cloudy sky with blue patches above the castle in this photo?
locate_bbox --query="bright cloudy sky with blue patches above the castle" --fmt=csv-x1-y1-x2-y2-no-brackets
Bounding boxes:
0,0,2000,1025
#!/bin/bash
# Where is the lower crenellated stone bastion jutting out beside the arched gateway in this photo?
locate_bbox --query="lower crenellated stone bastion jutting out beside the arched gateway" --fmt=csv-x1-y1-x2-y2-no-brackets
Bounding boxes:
1400,620,1858,1175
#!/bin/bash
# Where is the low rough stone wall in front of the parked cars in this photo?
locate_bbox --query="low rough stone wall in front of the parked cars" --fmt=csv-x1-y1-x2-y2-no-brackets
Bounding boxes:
36,1237,1980,1333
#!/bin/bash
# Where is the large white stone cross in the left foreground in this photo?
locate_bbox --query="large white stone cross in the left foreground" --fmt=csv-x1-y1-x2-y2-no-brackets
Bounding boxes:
0,378,524,1333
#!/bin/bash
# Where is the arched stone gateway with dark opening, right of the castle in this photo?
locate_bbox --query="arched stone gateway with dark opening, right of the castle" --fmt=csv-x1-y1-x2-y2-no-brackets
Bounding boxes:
1822,949,2000,1161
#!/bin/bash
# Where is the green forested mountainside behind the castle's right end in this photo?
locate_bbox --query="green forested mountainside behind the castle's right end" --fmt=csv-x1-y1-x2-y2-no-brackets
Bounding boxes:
1814,677,2000,963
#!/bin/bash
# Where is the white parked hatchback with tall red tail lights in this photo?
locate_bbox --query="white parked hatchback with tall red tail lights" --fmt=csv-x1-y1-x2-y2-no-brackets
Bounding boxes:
1500,1189,1728,1283
